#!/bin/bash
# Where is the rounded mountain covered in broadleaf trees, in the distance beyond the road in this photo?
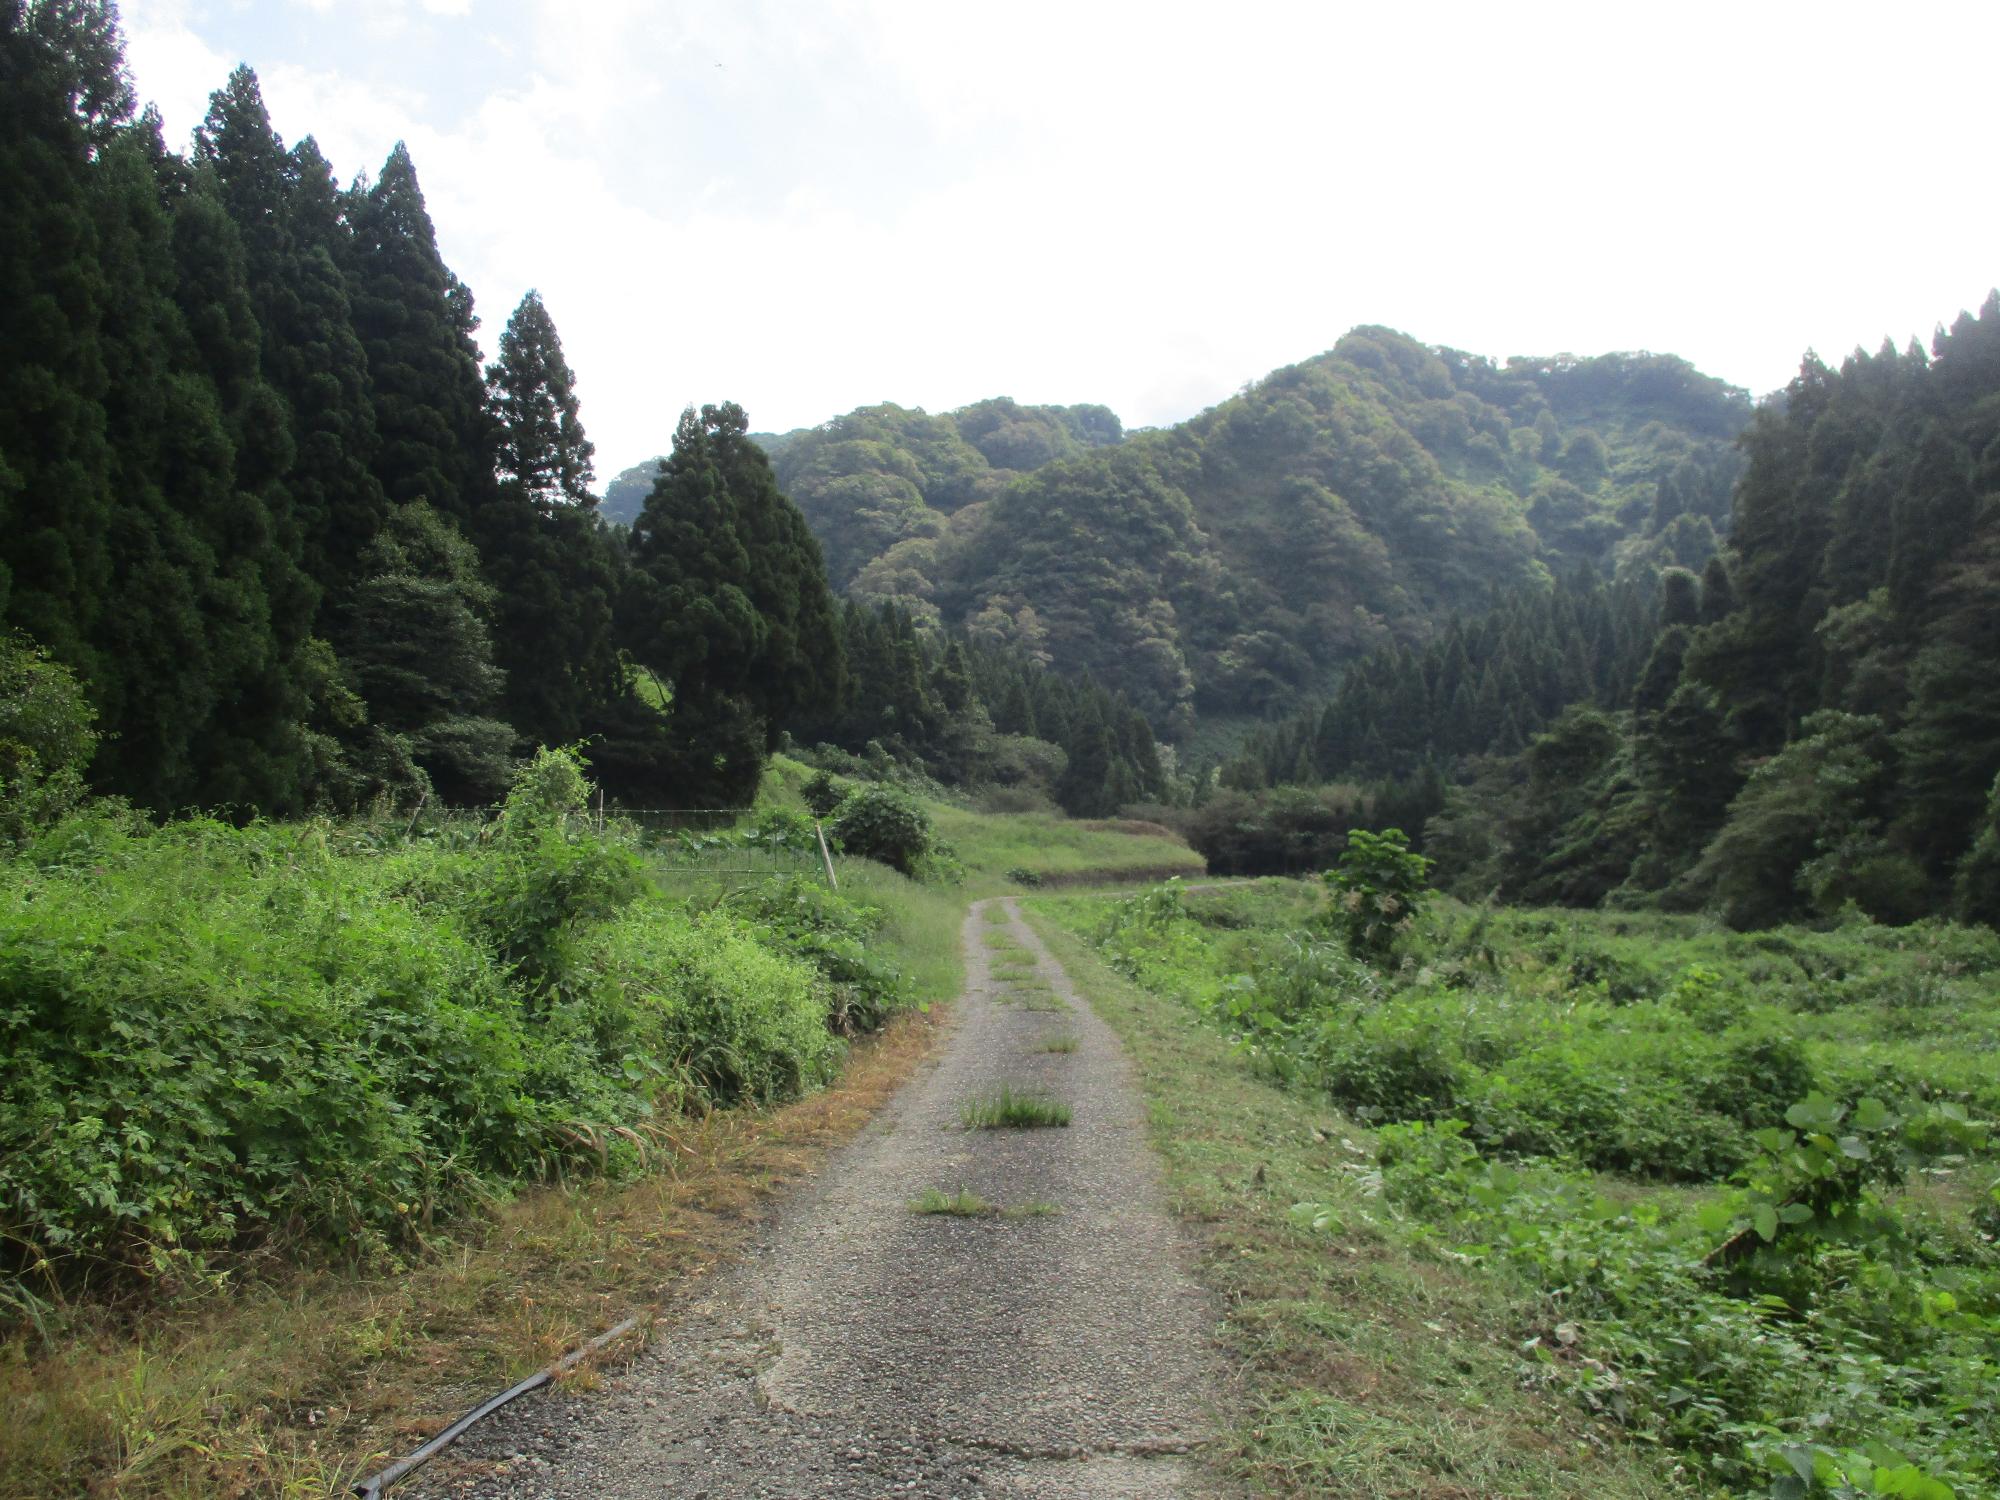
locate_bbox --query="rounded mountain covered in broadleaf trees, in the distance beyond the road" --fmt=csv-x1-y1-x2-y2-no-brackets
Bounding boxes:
668,328,1750,734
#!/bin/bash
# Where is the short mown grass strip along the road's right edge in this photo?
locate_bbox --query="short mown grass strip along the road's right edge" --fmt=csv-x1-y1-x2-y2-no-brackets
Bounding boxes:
1024,916,1690,1500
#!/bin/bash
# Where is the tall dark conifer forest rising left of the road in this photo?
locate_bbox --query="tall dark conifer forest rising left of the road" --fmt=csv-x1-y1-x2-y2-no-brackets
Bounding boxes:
0,0,1164,816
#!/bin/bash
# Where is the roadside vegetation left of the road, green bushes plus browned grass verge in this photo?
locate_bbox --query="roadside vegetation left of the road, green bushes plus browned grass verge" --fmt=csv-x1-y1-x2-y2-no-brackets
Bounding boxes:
0,740,1188,1500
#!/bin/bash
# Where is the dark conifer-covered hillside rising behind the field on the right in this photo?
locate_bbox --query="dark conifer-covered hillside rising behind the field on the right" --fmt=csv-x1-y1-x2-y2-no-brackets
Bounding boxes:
1224,296,2000,926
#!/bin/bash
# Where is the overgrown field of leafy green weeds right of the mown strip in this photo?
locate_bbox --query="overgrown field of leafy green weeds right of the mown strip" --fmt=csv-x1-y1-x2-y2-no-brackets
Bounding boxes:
1044,882,2000,1498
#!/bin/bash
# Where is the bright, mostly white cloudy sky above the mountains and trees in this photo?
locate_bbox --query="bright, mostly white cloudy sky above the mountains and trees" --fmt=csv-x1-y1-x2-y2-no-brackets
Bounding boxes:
122,0,2000,480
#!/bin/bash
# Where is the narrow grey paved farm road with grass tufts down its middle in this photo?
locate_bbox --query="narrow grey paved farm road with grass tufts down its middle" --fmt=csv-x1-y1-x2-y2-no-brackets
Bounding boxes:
424,900,1222,1500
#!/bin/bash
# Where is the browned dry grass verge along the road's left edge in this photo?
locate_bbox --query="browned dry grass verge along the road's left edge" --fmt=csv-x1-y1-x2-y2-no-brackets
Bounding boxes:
0,1014,940,1500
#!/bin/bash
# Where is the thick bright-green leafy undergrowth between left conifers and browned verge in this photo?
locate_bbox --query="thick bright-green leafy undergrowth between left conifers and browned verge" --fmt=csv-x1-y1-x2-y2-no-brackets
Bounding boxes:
0,750,930,1290
